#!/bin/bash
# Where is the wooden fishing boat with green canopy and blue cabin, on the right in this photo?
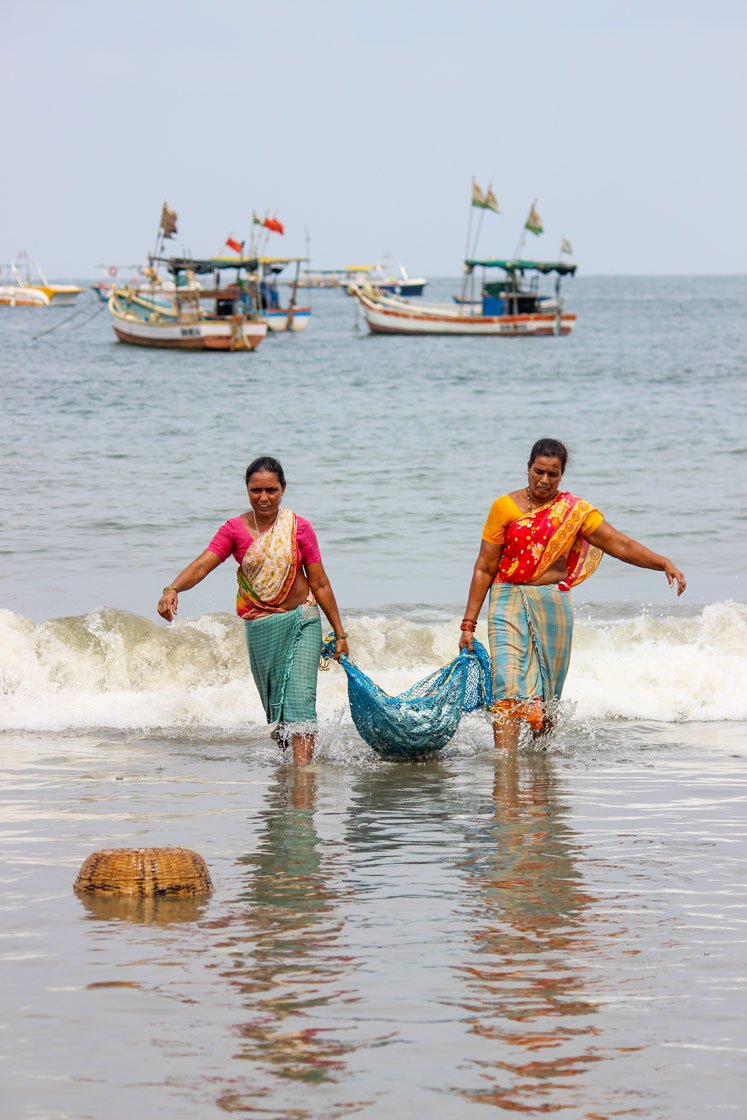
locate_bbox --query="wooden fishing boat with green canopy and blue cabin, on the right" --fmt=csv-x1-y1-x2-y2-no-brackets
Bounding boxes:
353,259,576,338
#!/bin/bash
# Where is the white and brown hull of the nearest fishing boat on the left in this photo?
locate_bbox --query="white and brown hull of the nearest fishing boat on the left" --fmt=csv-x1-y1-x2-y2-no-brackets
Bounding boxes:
109,292,268,351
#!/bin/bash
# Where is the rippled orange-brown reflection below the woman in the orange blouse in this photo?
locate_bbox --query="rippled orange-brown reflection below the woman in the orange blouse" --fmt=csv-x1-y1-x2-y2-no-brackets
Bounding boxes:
460,752,632,1116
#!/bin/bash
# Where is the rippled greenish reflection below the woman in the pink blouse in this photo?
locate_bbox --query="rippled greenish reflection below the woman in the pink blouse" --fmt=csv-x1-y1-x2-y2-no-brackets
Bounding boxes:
210,767,362,1117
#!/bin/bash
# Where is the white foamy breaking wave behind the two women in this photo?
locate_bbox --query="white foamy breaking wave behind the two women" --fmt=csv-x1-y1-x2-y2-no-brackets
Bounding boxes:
0,601,747,732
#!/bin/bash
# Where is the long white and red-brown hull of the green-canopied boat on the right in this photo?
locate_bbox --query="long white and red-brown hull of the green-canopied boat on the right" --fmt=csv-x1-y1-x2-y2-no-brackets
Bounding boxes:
353,289,576,338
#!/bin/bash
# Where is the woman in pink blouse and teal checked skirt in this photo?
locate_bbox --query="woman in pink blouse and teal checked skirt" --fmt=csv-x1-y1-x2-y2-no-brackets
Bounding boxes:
158,456,349,766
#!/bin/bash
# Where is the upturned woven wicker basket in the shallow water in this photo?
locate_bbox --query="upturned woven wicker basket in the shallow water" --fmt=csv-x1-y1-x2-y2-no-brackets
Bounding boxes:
74,848,213,898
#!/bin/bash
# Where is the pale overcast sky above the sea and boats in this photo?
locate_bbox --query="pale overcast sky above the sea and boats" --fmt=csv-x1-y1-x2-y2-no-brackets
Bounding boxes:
0,0,747,279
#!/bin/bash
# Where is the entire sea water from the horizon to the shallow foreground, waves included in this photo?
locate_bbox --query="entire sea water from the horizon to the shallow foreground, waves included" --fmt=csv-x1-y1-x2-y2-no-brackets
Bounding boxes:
0,277,747,1120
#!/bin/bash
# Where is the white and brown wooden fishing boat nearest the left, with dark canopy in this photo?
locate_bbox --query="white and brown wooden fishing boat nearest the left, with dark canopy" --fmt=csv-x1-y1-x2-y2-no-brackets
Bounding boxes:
109,256,268,351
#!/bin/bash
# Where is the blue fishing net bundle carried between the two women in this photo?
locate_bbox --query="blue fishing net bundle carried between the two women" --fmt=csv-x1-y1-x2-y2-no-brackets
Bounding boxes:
321,635,493,758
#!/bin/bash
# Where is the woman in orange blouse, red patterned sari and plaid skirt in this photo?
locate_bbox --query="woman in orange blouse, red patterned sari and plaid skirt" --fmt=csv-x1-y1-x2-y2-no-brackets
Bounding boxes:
459,439,685,747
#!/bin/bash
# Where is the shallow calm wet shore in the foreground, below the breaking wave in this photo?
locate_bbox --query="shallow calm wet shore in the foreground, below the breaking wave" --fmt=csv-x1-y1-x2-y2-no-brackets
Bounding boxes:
0,721,747,1120
